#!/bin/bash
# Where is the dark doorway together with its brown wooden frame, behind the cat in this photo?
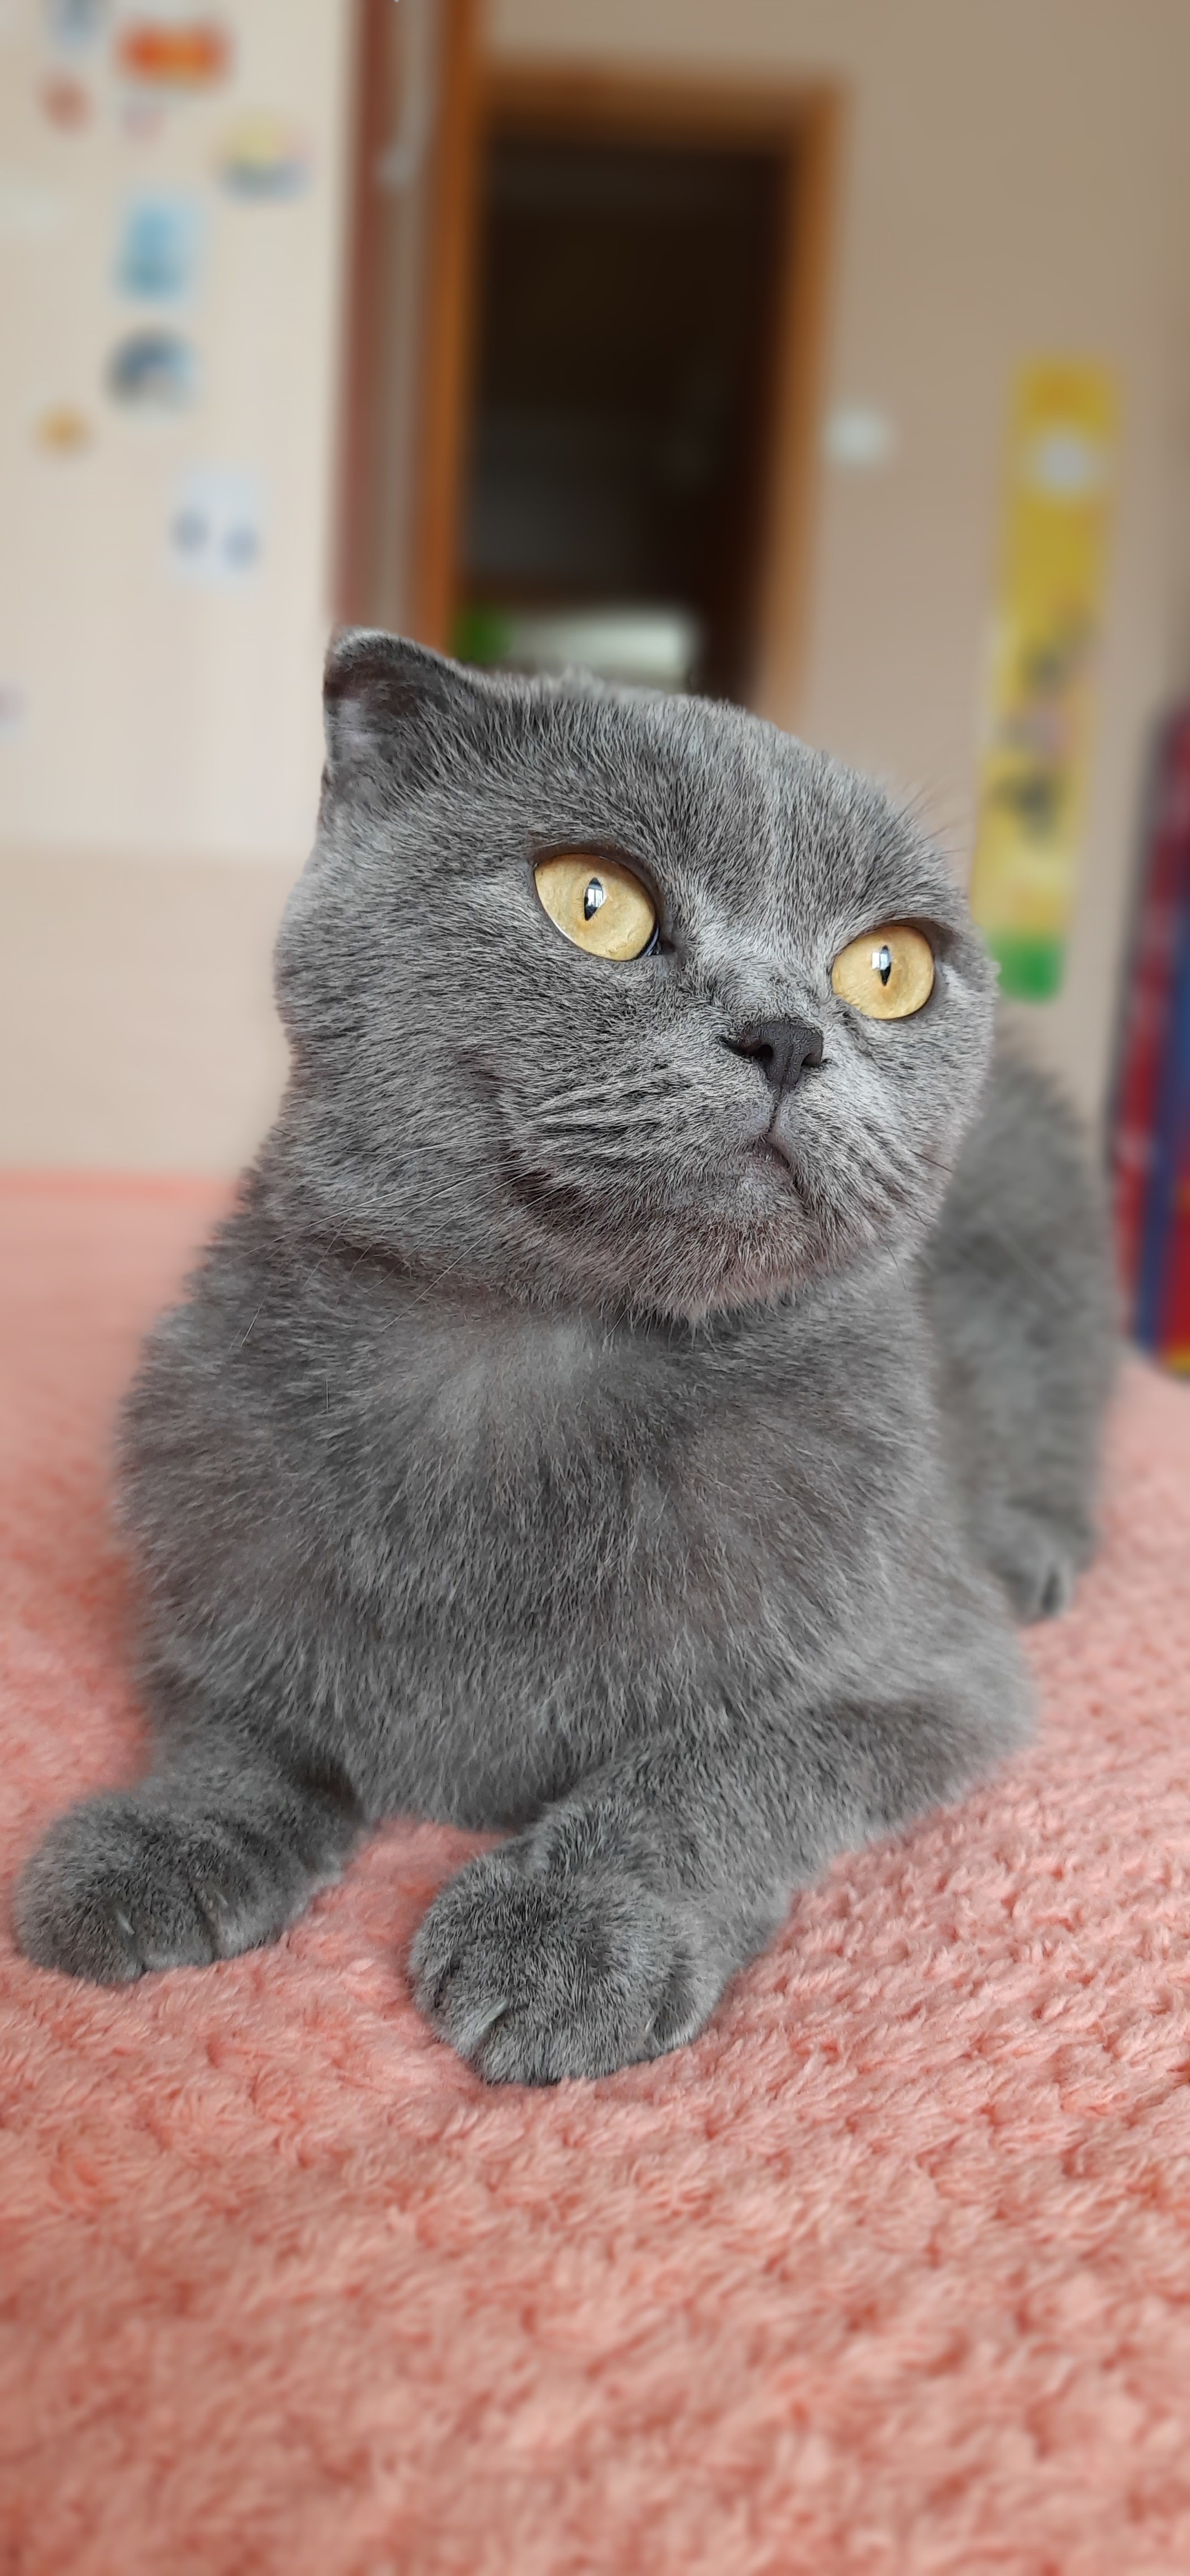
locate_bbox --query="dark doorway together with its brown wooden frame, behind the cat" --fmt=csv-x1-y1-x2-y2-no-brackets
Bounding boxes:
343,15,837,719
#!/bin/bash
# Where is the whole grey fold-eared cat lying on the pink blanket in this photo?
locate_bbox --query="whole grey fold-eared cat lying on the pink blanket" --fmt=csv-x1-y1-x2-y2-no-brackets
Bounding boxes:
18,634,1113,2081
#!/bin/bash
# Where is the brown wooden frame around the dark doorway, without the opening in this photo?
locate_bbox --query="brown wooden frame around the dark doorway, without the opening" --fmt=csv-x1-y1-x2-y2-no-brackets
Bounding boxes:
343,25,843,724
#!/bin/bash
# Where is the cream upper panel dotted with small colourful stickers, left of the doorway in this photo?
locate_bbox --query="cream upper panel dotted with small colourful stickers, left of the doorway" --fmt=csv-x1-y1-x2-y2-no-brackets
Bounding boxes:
0,0,347,858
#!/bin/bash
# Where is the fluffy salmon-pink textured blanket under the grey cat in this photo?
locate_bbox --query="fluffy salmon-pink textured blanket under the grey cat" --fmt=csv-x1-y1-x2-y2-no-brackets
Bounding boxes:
0,1183,1190,2576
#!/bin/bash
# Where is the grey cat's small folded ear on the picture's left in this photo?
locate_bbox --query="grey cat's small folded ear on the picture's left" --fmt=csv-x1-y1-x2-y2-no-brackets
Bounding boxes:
322,626,492,786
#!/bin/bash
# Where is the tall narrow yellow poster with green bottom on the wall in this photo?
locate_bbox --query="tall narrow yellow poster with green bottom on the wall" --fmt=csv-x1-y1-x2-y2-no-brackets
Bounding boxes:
971,361,1118,1002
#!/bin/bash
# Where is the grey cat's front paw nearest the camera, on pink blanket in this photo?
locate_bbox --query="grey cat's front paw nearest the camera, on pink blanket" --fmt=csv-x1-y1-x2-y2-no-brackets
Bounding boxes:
410,1844,721,2084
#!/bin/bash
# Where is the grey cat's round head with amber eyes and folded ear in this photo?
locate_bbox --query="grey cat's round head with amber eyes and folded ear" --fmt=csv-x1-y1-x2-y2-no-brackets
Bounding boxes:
275,634,992,1319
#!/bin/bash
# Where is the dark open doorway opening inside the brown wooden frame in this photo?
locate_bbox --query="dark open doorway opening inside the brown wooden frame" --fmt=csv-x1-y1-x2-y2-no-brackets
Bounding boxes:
456,116,783,698
